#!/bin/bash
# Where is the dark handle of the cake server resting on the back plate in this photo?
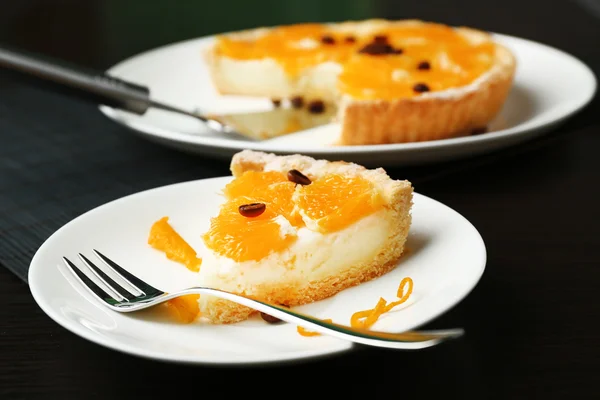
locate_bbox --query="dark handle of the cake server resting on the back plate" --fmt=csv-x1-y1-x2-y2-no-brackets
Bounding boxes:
0,47,152,115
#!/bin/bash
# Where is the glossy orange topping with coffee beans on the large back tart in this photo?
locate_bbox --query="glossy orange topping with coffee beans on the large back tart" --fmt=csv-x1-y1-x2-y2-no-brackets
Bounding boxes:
216,23,496,99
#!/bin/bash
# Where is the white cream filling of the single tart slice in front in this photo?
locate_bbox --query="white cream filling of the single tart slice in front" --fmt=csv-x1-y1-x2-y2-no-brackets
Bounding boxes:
199,209,390,293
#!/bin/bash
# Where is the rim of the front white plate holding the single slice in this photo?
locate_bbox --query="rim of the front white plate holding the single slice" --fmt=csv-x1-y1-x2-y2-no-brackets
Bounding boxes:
27,176,487,367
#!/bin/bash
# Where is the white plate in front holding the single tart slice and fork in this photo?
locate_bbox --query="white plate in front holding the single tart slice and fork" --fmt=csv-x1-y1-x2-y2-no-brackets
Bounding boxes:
29,178,486,364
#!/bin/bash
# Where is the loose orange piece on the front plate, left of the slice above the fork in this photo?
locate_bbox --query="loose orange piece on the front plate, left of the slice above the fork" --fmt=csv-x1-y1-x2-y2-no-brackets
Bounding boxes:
148,217,202,272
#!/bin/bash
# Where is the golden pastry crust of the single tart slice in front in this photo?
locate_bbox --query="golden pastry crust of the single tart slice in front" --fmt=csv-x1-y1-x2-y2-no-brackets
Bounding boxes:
200,150,413,324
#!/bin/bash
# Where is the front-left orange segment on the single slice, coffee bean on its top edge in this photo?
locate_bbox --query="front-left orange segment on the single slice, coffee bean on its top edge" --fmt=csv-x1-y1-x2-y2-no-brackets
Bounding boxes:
203,196,296,262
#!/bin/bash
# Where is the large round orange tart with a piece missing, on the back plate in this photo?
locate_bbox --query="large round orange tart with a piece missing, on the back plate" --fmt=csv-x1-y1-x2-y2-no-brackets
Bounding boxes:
206,19,516,145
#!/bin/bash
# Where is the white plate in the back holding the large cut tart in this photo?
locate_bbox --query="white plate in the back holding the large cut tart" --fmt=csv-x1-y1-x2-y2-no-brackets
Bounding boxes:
101,30,596,166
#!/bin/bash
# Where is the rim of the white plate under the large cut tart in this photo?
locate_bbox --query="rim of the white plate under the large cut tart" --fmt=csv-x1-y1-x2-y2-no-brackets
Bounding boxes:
99,31,598,156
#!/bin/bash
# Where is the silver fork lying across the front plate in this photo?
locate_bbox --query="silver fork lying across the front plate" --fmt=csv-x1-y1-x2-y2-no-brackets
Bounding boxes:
63,250,464,350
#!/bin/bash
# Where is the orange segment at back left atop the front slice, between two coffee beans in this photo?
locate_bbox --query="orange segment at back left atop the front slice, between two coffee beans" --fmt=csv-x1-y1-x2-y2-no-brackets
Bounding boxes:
223,171,303,226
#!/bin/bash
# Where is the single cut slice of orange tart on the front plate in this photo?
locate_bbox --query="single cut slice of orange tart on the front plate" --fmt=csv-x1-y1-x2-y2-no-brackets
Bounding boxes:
198,150,413,323
